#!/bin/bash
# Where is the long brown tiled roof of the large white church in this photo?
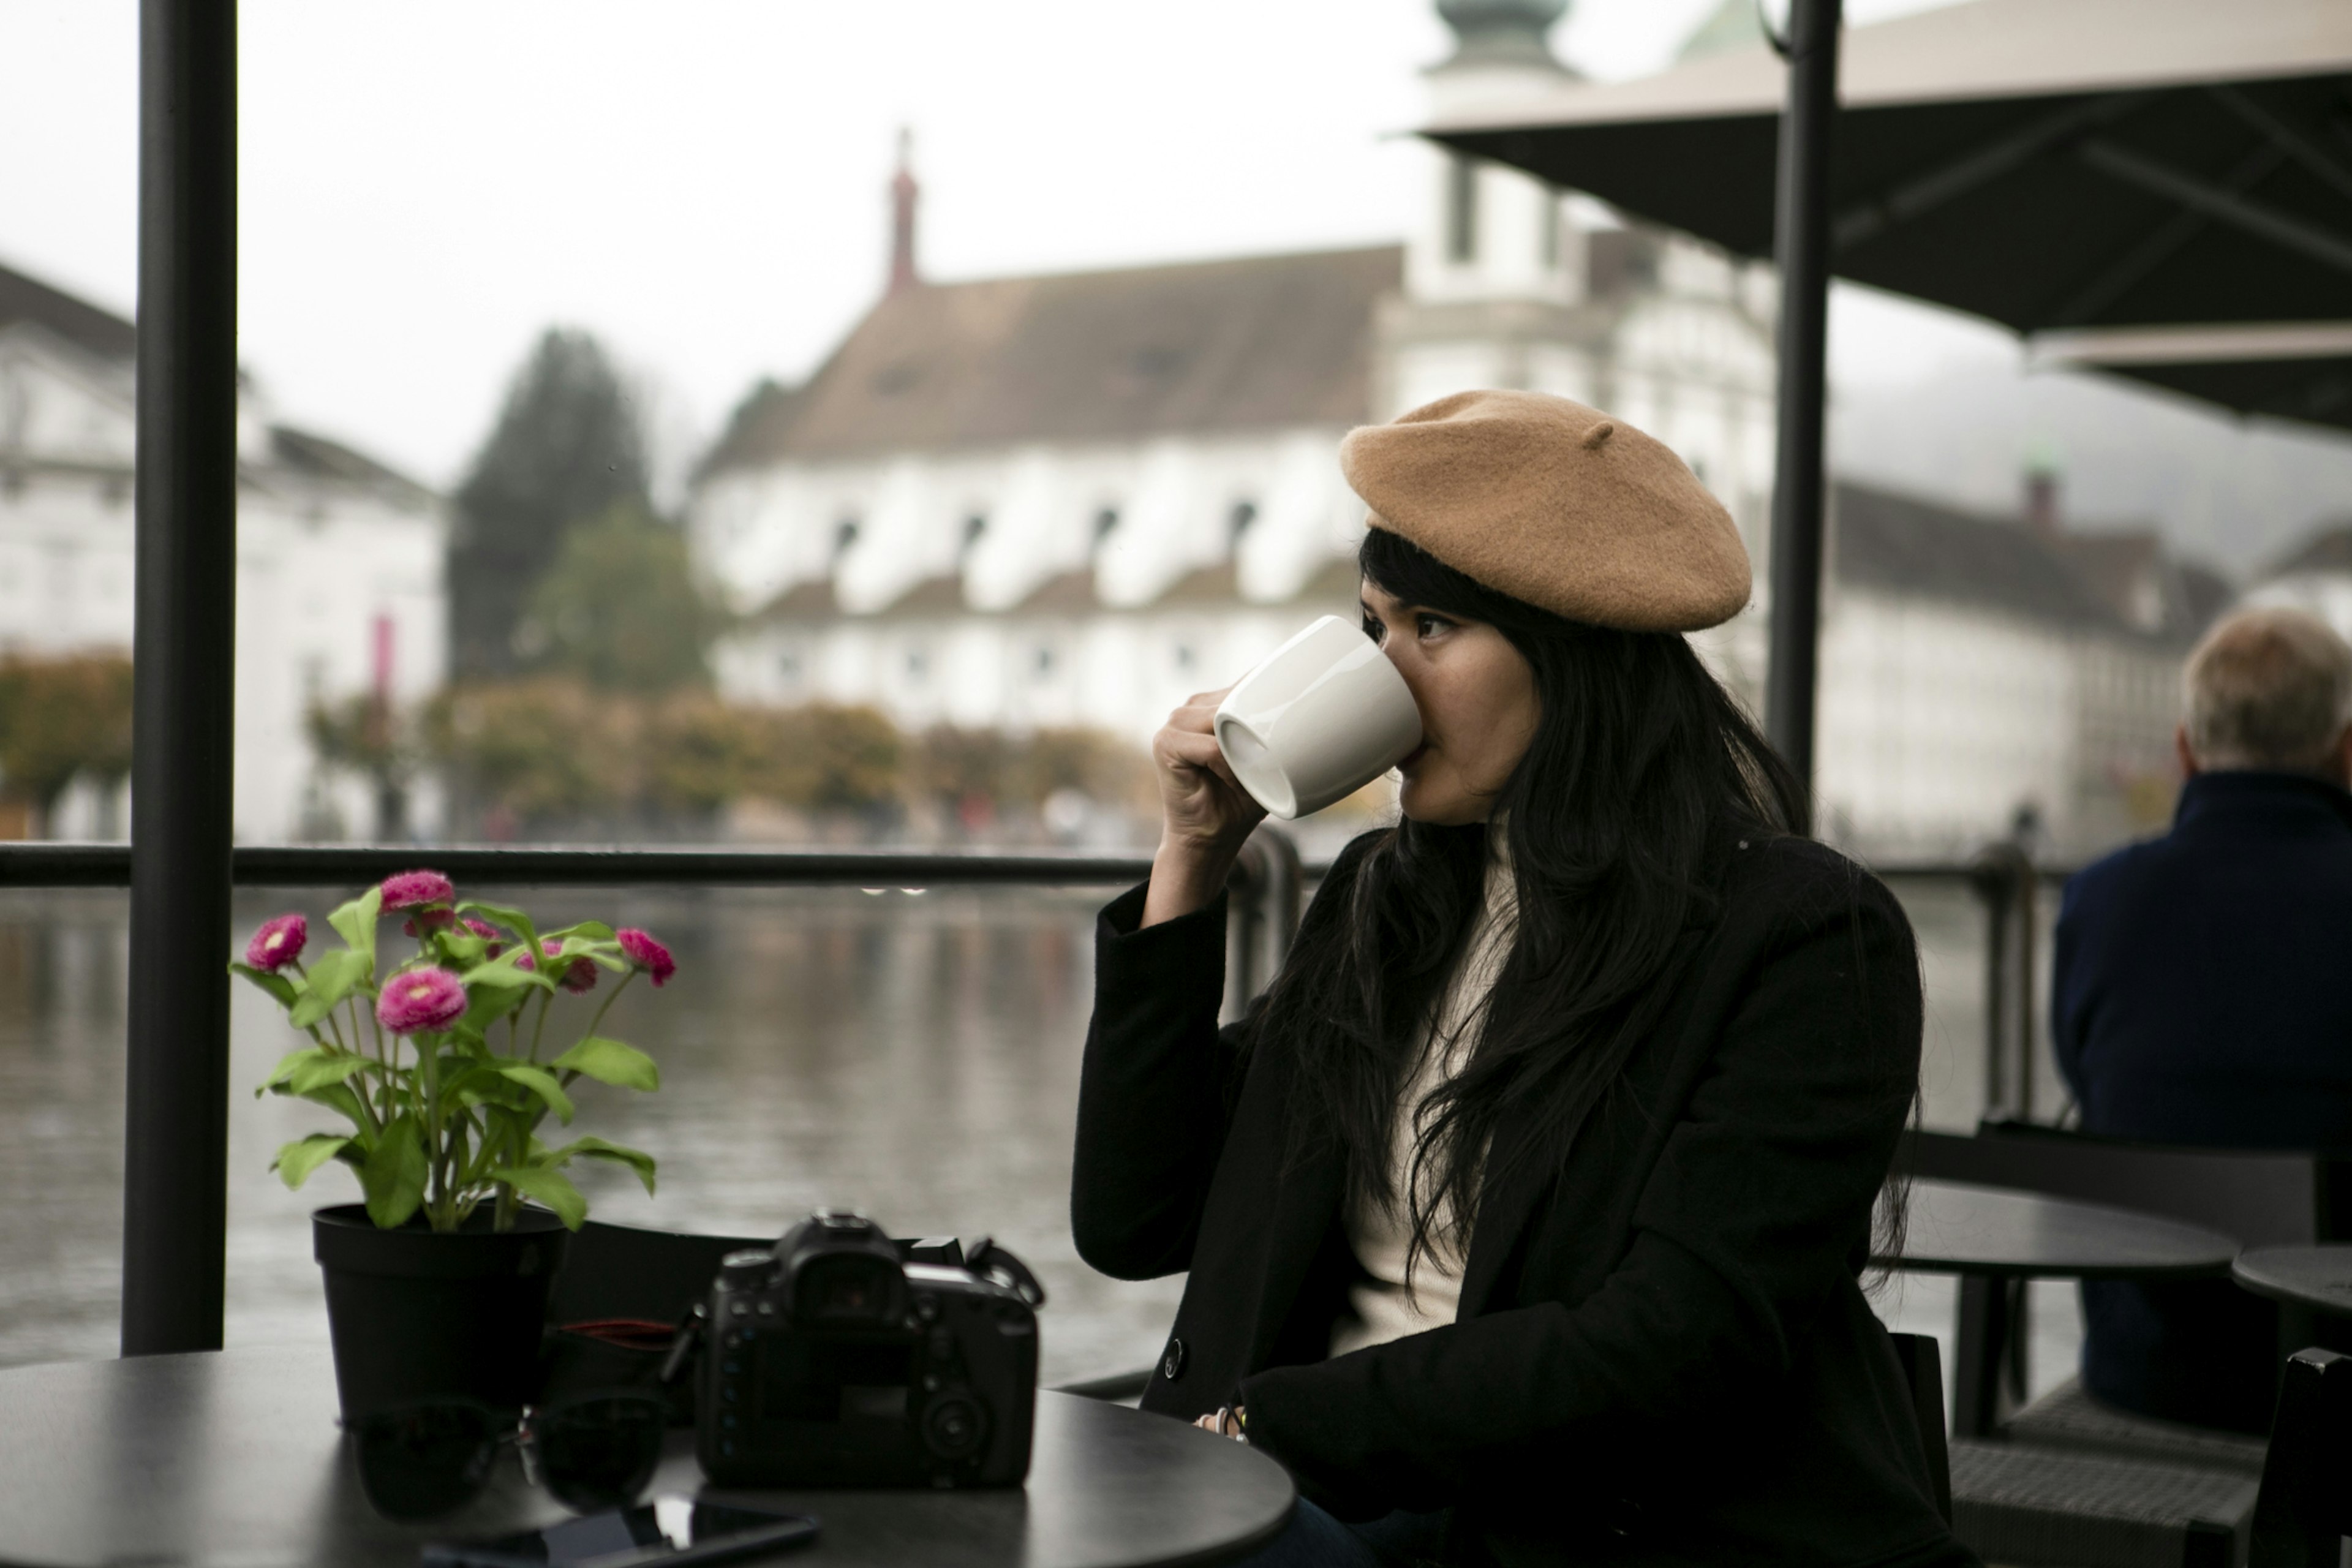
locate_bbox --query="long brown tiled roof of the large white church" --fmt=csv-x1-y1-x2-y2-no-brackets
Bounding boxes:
703,244,1404,472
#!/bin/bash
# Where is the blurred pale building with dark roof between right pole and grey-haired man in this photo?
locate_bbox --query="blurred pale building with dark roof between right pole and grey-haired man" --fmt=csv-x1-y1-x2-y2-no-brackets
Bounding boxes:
1818,475,2230,858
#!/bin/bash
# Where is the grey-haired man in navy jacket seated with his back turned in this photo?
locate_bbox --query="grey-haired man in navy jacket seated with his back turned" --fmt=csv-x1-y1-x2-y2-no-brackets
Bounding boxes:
2051,609,2352,1431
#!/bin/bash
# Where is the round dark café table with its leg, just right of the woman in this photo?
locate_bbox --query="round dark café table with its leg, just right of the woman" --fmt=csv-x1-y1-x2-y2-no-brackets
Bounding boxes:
1874,1180,2237,1436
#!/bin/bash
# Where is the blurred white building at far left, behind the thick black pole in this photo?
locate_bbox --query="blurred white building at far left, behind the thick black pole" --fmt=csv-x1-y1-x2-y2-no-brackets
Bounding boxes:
0,268,447,842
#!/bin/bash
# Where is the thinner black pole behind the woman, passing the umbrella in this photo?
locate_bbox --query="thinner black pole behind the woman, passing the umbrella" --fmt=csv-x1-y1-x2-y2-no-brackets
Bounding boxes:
1764,0,1844,809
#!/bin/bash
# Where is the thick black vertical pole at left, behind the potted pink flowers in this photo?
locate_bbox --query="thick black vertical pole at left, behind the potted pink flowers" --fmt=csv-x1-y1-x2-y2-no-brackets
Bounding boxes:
123,0,238,1357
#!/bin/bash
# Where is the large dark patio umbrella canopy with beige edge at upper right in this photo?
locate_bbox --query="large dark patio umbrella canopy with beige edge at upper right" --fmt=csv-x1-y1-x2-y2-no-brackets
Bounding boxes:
1428,0,2352,423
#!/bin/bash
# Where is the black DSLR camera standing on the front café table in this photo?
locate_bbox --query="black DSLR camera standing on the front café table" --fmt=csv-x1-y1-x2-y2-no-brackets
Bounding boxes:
694,1208,1037,1488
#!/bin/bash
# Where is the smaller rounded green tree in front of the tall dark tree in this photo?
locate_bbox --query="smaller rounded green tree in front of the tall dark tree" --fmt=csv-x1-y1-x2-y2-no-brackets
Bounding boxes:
515,499,720,693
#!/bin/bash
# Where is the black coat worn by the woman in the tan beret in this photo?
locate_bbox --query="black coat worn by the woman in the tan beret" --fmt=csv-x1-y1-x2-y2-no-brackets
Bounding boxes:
1070,839,1973,1566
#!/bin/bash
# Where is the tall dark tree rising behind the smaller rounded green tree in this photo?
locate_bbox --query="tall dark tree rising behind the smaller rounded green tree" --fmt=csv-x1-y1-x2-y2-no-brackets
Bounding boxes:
449,326,647,677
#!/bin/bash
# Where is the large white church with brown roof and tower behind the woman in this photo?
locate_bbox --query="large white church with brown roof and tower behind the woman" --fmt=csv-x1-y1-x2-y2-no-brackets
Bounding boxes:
689,0,1771,738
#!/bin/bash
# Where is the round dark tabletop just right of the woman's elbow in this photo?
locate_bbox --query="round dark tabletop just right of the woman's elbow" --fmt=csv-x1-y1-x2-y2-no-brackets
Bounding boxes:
1877,1180,2237,1279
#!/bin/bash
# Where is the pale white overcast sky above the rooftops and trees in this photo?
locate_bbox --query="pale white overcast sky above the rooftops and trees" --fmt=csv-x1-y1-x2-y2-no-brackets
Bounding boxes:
0,0,2008,484
